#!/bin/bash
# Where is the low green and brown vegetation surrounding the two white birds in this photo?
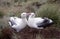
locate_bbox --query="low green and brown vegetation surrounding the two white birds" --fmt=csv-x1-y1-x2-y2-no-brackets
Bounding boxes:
0,0,60,39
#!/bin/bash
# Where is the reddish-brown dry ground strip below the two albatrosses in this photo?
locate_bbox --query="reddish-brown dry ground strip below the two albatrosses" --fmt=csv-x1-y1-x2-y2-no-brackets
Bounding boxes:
2,27,60,39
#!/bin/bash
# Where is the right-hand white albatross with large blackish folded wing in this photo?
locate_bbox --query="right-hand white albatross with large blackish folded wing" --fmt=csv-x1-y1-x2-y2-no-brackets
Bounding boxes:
27,13,53,29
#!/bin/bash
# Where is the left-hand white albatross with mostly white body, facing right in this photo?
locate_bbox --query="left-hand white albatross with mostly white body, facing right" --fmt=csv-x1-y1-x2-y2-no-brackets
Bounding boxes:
9,13,27,32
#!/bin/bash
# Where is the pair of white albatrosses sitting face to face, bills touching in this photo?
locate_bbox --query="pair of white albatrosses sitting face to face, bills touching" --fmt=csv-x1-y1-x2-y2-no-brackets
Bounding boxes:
9,13,53,32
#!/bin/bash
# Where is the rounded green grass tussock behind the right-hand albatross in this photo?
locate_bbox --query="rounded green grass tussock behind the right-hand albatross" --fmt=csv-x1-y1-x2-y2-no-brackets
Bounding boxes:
36,4,60,27
